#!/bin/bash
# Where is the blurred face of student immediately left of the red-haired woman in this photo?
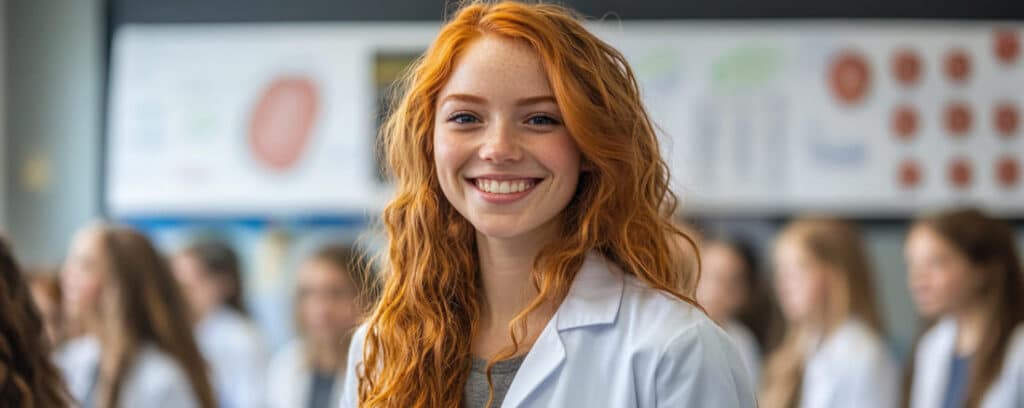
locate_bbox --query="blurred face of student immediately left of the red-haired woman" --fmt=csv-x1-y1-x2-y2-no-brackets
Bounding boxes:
298,259,359,342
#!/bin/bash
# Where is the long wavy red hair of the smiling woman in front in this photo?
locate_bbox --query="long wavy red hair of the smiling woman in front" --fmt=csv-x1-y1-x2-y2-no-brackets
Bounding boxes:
356,2,695,407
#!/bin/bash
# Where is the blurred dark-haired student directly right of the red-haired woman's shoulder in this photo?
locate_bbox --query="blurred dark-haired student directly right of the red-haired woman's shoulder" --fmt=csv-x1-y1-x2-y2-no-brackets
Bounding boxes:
697,238,761,384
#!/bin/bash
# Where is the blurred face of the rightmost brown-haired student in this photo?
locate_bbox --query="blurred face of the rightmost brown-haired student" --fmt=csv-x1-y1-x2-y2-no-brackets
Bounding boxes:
904,225,983,318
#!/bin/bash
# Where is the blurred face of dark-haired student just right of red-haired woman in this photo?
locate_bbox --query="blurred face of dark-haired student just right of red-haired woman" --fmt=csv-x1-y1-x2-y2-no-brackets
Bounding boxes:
697,243,750,322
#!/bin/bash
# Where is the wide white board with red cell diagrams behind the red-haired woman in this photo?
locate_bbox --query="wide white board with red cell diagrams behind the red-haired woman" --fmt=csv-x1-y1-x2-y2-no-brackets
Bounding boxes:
106,21,1024,215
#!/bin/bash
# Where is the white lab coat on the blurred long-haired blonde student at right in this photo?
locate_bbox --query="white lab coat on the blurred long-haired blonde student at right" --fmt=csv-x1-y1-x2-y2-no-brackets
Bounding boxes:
801,319,900,408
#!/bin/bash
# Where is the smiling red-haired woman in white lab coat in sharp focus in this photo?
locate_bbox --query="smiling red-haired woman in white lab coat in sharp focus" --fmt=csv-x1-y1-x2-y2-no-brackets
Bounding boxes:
342,2,755,408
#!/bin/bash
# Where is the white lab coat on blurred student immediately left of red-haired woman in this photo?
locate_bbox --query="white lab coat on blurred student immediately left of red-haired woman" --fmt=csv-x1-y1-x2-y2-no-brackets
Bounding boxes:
266,340,344,408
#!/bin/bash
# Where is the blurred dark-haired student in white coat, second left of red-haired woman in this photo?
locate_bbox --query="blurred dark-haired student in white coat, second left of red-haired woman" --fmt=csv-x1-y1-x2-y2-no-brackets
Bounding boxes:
171,241,267,408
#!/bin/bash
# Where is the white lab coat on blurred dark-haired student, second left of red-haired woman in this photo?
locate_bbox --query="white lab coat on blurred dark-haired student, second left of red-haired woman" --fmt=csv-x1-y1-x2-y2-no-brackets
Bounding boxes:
196,307,267,408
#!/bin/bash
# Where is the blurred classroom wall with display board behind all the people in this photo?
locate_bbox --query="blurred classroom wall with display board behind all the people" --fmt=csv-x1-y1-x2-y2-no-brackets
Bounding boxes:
0,0,1024,371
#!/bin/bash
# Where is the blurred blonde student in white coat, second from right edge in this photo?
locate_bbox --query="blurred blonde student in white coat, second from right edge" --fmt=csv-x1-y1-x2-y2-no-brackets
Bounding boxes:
759,217,899,408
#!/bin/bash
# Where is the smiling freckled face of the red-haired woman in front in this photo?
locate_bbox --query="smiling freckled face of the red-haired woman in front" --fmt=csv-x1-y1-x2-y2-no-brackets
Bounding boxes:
434,36,581,238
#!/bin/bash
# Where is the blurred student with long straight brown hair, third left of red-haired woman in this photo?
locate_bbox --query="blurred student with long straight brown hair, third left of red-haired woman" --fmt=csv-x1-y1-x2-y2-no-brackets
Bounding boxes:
58,225,216,408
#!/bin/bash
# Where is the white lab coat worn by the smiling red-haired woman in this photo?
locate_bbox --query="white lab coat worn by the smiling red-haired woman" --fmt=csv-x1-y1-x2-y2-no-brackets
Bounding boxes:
341,253,756,408
